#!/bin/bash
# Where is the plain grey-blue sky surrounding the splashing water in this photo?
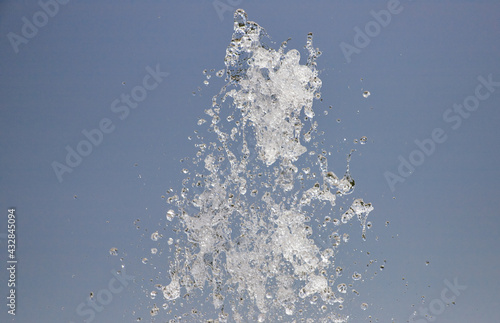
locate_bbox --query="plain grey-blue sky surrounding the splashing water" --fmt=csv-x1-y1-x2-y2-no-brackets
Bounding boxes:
0,0,500,322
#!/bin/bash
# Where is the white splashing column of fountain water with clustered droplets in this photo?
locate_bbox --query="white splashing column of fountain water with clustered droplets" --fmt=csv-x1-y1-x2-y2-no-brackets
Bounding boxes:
151,10,373,322
